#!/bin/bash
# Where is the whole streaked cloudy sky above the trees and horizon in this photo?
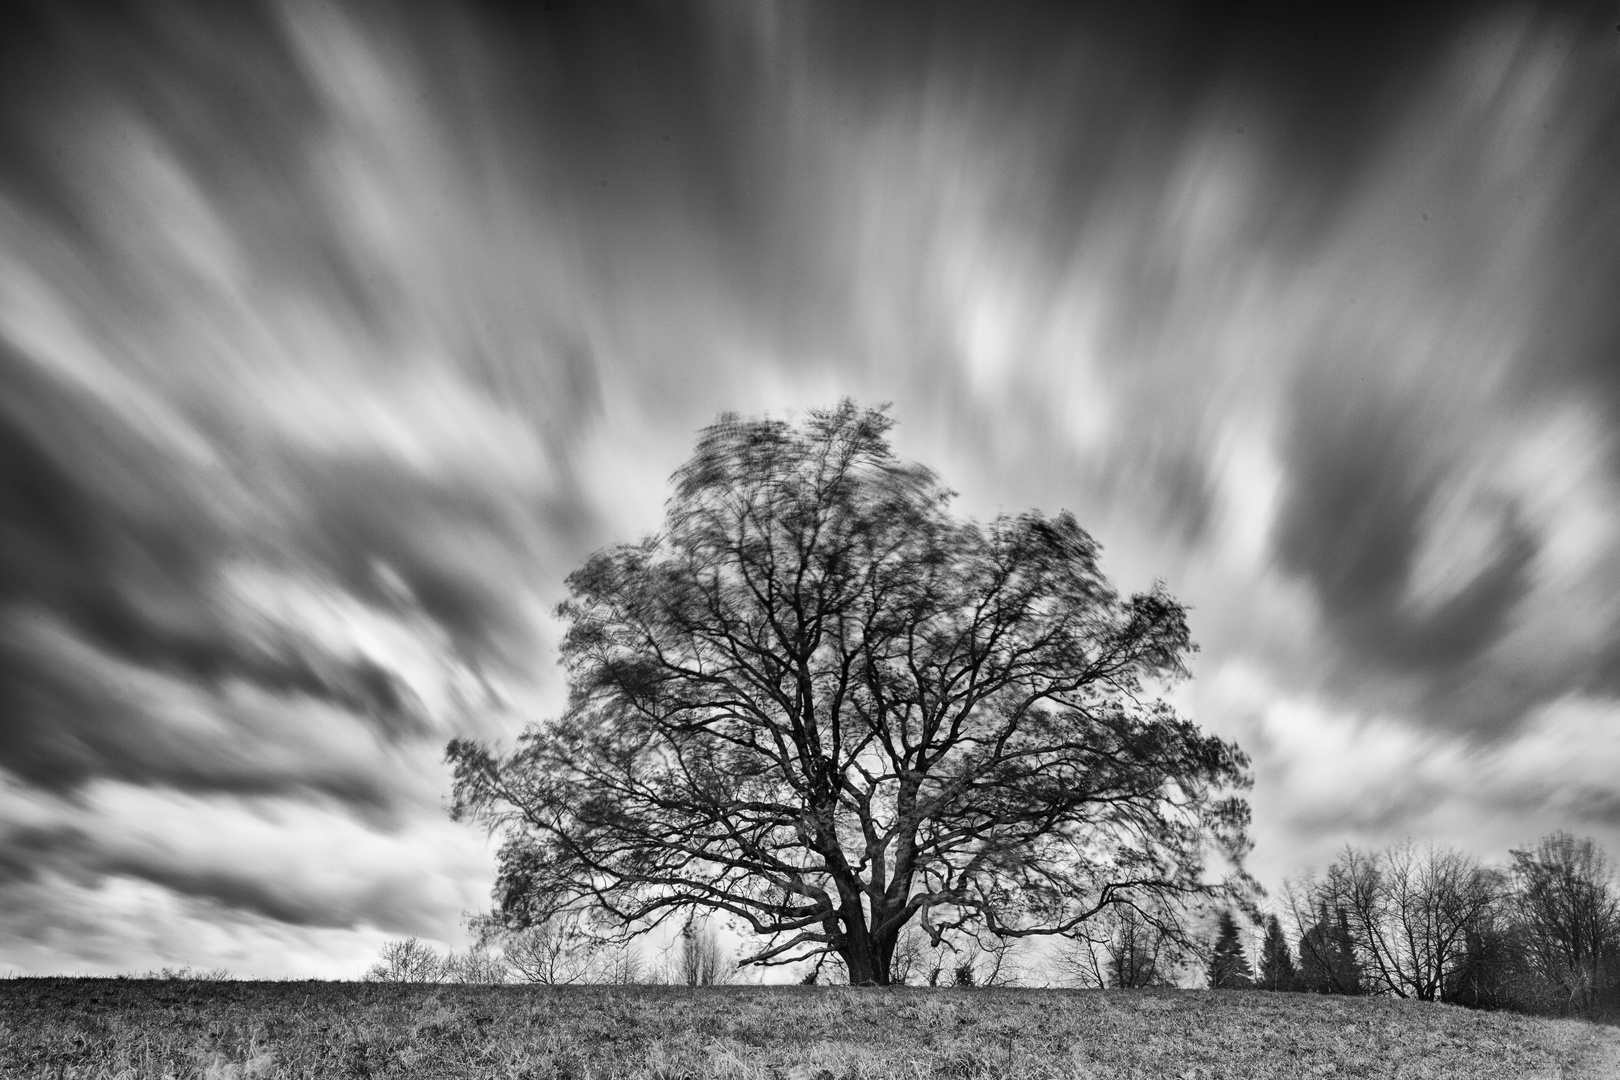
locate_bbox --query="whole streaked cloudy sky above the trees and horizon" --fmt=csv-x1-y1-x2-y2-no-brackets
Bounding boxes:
0,0,1620,978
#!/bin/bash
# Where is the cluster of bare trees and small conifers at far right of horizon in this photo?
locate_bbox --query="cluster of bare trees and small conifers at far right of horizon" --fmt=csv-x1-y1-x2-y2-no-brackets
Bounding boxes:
1207,832,1620,1020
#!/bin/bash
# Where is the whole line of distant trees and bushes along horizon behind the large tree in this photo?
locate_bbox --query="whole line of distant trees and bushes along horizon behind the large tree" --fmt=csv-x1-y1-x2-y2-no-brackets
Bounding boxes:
366,832,1620,1020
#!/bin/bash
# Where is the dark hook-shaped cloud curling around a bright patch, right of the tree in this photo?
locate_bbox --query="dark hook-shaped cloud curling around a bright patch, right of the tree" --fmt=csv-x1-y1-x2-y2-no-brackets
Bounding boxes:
1273,379,1537,678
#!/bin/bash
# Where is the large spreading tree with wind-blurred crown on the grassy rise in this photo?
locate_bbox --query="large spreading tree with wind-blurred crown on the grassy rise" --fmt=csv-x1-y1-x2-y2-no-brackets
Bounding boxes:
449,402,1249,984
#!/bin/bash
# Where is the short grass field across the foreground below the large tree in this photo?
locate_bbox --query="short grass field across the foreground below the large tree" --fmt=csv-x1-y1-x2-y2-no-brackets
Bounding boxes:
0,980,1620,1080
